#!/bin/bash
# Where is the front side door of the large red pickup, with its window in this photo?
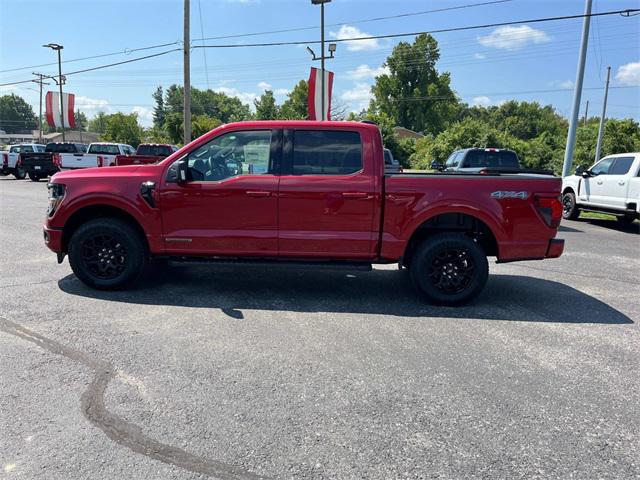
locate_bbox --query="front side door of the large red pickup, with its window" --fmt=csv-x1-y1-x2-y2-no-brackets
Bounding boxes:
160,130,282,256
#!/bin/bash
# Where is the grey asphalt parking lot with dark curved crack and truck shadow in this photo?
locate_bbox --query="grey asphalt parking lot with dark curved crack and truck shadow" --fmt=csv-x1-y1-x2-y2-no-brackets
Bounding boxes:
0,177,640,479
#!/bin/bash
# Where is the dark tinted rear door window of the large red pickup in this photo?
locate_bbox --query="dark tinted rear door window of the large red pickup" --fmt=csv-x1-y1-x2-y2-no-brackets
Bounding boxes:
293,130,362,175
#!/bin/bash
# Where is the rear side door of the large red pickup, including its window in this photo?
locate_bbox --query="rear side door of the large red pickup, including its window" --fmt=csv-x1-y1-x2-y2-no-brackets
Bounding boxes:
278,124,381,259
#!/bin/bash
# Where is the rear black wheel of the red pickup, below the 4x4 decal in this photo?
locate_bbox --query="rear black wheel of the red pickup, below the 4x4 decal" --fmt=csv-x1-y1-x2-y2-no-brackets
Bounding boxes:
409,233,489,305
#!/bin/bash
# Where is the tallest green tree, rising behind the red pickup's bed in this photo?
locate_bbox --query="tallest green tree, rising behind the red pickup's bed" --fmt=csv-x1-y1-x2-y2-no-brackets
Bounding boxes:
369,34,459,134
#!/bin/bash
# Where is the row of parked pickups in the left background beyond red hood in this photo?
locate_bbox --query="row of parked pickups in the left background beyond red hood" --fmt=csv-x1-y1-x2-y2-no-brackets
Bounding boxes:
0,142,177,182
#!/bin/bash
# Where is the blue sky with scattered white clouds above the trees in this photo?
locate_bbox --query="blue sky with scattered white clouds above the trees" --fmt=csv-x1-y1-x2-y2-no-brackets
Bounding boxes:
0,0,640,125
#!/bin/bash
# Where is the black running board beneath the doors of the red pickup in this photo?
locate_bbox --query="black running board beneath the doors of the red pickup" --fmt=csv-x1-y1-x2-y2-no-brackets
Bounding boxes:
165,257,373,272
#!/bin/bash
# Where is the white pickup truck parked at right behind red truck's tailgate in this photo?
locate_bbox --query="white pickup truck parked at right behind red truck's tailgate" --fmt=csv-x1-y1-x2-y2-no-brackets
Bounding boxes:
562,153,640,224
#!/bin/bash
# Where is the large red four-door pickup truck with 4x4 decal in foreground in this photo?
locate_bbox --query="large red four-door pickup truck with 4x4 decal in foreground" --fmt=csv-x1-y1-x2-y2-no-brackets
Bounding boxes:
44,121,564,304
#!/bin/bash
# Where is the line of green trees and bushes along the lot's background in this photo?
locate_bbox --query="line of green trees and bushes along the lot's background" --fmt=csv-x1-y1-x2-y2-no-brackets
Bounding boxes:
0,34,640,173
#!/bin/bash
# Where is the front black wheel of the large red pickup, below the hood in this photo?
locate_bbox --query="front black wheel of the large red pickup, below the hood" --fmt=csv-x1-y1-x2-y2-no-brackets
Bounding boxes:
69,218,148,290
